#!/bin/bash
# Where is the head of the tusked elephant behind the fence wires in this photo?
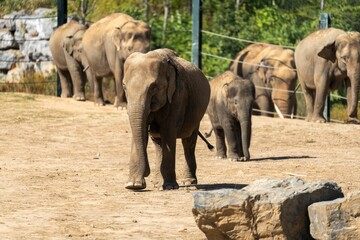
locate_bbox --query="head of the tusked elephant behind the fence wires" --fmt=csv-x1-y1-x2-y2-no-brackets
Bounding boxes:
255,50,297,115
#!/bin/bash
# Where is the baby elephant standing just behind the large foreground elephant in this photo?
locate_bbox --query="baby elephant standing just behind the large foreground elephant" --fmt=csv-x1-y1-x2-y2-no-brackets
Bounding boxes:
207,71,255,161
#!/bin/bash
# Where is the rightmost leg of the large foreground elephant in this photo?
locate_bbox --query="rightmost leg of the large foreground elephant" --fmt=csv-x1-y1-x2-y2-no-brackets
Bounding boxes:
182,128,198,186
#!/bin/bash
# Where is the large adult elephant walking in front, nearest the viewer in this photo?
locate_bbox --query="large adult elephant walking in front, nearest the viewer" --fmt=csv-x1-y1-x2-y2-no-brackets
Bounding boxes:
124,49,210,189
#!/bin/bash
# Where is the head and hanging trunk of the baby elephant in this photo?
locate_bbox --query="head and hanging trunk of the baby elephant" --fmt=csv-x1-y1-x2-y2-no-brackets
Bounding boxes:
223,77,255,161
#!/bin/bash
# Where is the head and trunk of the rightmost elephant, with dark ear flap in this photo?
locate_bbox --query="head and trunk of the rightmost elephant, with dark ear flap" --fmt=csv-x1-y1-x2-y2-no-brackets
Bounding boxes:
318,32,360,122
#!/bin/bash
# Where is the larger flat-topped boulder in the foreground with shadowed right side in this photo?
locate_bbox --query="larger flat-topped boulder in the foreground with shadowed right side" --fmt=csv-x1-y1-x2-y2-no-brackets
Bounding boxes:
193,178,343,240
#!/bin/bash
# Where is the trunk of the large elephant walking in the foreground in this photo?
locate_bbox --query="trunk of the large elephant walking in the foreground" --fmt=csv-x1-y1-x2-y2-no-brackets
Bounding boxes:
128,104,150,177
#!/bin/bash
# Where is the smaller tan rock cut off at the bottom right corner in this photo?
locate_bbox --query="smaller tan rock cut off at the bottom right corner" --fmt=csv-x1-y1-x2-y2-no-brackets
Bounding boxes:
308,191,360,240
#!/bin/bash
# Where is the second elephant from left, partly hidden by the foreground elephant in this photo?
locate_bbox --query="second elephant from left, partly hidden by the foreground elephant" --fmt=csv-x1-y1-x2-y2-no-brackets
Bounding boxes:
83,13,150,107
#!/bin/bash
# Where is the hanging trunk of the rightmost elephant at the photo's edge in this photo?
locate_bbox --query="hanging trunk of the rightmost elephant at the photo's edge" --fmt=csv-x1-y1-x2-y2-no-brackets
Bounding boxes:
347,70,360,120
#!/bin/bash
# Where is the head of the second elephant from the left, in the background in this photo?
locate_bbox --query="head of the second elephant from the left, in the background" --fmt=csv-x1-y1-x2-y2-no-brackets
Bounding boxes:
112,20,151,59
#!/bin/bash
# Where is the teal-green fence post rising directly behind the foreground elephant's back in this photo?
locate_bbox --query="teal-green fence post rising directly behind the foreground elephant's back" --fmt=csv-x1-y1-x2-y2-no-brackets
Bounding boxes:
191,0,202,69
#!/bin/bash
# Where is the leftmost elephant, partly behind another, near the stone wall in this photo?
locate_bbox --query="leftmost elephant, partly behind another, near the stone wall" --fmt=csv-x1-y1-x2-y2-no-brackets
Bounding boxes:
49,20,93,101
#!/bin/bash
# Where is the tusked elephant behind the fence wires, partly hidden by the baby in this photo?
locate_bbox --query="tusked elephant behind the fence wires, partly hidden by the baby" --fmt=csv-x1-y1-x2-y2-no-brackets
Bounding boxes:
230,43,297,117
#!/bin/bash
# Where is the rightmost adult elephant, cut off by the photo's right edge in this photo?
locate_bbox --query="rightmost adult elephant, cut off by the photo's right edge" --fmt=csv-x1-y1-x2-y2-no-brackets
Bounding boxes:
295,28,360,123
